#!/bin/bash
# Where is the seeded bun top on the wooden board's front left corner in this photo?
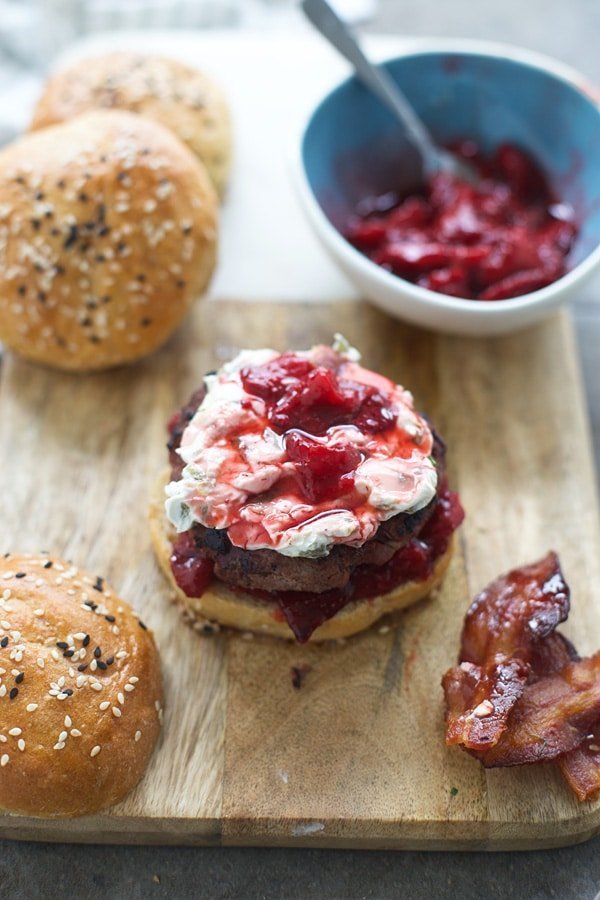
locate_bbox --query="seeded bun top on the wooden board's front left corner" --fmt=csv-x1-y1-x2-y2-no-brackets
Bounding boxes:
0,555,163,817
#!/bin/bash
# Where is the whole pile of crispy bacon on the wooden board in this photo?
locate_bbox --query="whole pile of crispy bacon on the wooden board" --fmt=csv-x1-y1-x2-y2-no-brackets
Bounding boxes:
442,553,600,800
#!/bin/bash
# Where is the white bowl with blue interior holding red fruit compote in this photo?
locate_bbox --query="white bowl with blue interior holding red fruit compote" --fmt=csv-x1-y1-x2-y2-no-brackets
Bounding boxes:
296,41,600,336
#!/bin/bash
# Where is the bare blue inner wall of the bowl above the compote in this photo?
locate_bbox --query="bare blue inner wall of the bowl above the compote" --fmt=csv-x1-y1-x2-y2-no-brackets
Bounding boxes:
301,52,600,266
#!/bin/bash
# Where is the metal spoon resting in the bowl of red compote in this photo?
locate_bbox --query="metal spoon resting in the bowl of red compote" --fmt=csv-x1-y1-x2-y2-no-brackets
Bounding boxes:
301,0,478,182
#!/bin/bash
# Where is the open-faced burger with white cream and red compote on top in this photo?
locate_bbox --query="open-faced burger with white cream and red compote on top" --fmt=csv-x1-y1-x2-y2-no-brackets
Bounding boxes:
150,335,464,643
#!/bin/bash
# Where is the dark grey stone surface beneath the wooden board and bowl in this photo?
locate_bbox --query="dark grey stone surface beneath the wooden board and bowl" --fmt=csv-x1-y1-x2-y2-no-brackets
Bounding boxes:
0,0,600,900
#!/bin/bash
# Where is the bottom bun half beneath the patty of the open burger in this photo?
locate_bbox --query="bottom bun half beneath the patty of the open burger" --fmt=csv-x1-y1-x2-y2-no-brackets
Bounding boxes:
150,472,452,641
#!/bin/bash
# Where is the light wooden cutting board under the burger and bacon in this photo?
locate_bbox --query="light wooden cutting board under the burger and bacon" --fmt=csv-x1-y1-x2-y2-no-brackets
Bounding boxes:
0,302,600,849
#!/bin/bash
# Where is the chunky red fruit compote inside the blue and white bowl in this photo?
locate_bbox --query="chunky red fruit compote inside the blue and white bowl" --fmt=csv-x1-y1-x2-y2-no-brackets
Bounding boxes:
345,141,577,301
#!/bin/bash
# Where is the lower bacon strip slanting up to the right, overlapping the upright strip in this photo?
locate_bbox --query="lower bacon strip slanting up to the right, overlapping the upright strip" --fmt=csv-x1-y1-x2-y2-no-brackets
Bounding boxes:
477,653,600,768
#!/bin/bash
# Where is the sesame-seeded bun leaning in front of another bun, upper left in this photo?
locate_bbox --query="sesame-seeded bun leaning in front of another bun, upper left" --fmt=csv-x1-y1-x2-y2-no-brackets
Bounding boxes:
0,111,217,370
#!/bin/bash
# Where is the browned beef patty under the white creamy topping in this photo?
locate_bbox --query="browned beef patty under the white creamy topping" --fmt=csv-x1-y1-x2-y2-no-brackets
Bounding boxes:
167,388,446,594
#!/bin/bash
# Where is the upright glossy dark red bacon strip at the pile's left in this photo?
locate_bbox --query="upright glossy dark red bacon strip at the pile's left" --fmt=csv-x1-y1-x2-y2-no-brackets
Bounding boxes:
442,552,569,751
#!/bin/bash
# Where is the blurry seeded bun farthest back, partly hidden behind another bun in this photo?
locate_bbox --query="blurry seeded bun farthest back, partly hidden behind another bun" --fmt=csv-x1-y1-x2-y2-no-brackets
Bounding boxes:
31,53,231,195
